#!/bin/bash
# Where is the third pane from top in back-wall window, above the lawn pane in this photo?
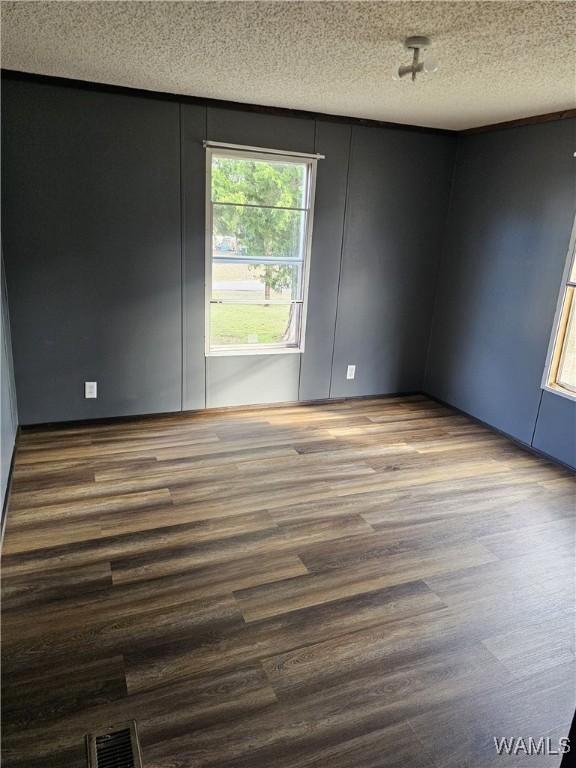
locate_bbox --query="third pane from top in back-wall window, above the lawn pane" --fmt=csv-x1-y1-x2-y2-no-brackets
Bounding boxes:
212,260,302,302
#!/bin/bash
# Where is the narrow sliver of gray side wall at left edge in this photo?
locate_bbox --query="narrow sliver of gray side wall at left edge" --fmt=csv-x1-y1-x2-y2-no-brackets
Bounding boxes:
0,252,18,522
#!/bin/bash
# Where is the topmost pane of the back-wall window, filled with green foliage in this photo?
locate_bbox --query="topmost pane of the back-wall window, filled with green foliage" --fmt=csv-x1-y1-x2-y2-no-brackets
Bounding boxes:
212,156,307,208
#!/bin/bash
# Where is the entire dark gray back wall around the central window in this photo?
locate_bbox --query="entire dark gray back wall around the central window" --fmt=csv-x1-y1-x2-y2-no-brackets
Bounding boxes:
2,79,455,424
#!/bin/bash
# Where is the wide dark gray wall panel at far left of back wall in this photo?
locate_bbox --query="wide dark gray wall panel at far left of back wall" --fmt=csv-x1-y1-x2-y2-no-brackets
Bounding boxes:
2,81,182,424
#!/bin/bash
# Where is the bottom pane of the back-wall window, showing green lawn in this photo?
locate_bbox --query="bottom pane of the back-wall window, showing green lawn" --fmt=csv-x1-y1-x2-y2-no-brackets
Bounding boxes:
210,304,302,348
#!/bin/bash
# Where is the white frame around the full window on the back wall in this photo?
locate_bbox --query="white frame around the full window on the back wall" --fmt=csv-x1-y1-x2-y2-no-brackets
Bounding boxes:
204,142,323,357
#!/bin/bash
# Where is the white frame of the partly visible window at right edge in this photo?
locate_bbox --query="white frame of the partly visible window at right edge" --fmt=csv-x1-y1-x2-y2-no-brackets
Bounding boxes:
542,213,576,400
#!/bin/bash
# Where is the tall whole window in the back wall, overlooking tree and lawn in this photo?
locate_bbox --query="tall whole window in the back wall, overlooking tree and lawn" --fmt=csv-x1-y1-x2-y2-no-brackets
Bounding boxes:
206,146,316,354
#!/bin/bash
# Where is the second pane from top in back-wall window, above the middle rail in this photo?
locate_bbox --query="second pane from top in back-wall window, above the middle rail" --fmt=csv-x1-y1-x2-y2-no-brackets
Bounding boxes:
212,204,306,260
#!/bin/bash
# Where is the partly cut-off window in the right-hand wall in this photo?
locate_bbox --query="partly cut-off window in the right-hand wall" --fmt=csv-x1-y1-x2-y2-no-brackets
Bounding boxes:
545,231,576,398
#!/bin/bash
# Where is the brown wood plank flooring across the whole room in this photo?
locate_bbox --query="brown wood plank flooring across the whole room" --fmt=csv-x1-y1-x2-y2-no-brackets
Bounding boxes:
2,396,576,768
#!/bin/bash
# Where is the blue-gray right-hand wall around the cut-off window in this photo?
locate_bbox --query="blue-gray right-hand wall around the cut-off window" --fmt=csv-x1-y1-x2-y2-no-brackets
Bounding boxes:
425,120,576,466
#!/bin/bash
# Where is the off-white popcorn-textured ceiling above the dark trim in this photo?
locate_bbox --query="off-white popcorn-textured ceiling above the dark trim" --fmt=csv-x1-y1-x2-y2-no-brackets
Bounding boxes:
2,0,576,129
